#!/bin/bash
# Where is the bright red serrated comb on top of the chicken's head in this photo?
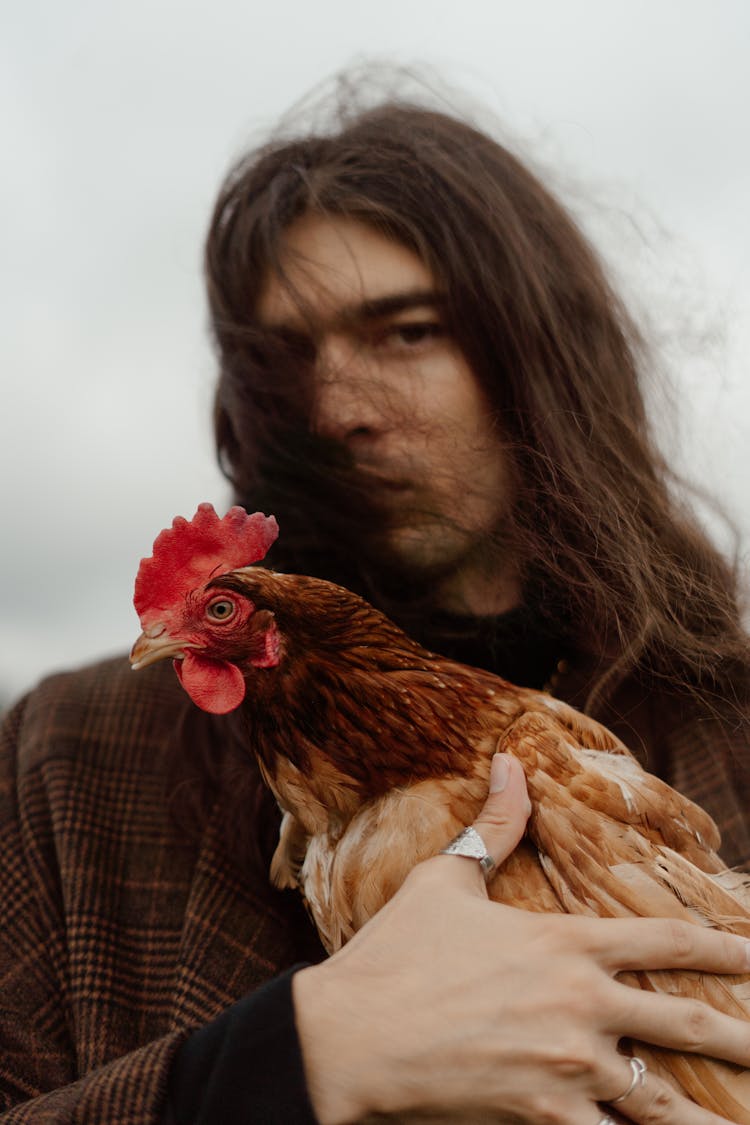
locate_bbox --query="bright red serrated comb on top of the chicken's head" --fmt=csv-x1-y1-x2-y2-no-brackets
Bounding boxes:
133,504,279,628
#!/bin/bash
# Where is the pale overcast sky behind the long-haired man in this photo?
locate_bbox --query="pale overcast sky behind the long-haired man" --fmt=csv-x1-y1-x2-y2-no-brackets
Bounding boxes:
0,0,750,696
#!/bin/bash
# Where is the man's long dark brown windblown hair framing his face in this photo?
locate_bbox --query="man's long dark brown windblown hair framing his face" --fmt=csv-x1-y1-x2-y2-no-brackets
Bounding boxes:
206,92,750,707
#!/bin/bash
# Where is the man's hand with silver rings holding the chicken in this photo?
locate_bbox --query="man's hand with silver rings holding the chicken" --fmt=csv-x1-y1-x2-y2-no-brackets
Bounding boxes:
292,755,750,1125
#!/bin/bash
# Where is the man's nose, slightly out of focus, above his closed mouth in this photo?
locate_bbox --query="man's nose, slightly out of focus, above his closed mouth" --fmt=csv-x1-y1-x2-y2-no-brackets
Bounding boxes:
313,336,383,446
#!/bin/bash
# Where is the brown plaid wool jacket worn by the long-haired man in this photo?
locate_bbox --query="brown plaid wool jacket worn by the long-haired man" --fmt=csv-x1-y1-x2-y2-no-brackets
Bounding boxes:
0,659,750,1125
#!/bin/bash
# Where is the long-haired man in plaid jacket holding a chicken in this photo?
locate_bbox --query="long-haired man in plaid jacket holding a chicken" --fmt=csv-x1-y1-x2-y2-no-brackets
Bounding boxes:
0,92,750,1125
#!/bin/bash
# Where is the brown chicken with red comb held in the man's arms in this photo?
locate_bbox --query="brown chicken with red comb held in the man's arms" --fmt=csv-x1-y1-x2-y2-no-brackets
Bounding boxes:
130,504,750,1125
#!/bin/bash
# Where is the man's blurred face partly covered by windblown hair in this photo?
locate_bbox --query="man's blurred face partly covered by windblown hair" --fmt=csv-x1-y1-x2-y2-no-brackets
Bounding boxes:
256,214,517,613
